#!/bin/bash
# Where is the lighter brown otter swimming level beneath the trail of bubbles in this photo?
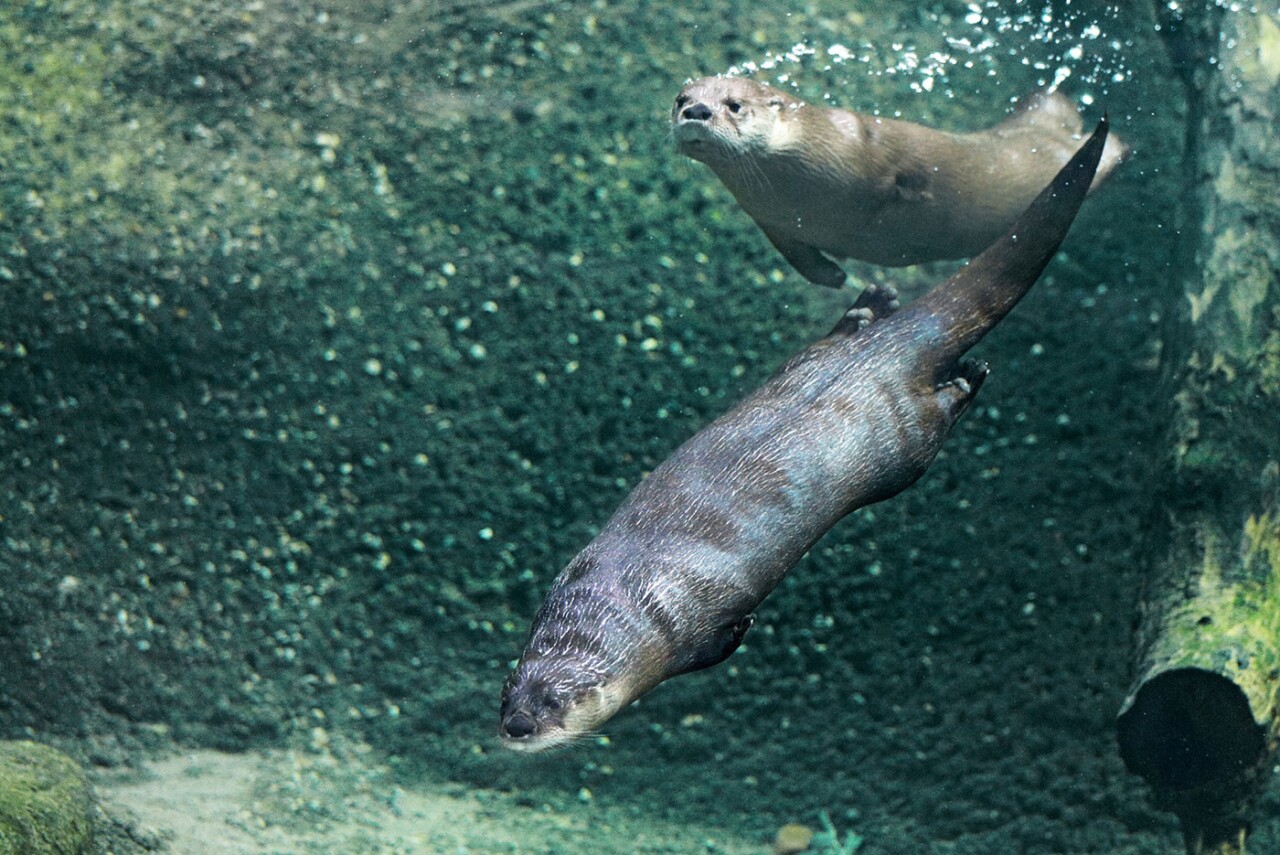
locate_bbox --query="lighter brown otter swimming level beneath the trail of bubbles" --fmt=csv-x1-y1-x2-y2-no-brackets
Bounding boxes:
671,77,1128,288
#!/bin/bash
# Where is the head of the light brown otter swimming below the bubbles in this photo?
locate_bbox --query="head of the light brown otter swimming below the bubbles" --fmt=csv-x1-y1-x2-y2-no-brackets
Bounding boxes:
671,77,801,165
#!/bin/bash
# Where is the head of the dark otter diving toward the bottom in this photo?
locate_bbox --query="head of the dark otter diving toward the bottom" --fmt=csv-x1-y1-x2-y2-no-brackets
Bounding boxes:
498,651,632,751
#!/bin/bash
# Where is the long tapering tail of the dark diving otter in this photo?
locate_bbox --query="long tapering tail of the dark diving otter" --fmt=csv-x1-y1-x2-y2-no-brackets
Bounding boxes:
901,118,1108,370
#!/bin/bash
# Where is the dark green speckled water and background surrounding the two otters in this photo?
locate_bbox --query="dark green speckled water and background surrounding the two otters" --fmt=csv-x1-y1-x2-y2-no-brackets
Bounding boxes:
0,0,1259,855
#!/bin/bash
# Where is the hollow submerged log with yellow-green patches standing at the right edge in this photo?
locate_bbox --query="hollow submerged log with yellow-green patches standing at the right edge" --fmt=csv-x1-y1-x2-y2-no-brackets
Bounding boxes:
1117,0,1280,855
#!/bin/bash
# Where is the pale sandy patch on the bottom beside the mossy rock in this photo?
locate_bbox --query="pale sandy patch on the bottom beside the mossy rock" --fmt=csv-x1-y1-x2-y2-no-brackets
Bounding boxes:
96,747,772,855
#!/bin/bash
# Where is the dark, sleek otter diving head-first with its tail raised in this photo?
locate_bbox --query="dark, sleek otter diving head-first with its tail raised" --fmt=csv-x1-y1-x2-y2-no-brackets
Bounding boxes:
499,119,1107,750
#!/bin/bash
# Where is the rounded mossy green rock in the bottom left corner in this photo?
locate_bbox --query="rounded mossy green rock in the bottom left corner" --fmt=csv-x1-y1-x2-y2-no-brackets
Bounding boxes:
0,742,93,855
